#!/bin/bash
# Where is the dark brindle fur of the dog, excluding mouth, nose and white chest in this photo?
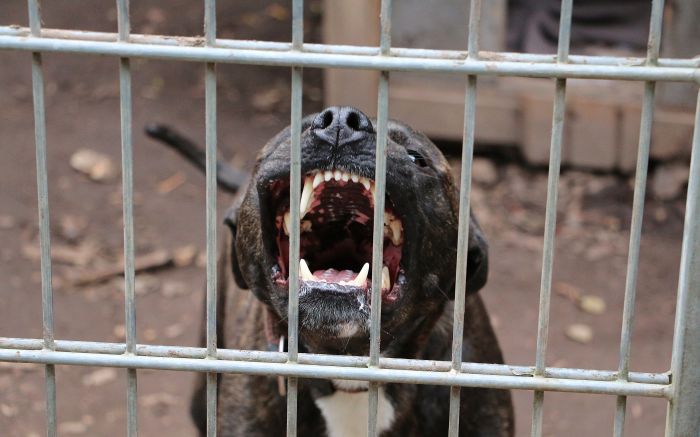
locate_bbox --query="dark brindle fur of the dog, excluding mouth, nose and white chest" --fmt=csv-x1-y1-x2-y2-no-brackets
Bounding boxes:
175,108,513,437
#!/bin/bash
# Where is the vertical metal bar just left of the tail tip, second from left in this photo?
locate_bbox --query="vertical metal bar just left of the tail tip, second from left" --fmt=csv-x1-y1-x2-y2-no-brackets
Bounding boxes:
117,0,138,437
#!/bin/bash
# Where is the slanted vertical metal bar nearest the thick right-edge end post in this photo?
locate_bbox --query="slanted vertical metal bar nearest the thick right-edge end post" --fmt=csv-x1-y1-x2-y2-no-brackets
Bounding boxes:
613,0,664,437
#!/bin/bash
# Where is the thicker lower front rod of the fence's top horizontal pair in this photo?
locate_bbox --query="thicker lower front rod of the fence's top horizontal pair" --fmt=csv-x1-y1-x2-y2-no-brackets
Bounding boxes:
0,36,700,83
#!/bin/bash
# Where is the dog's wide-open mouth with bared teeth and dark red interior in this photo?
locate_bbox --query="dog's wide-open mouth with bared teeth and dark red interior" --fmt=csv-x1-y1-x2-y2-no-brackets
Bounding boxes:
269,170,404,302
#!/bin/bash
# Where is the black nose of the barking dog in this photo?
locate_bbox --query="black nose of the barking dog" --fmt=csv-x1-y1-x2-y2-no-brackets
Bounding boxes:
311,106,374,146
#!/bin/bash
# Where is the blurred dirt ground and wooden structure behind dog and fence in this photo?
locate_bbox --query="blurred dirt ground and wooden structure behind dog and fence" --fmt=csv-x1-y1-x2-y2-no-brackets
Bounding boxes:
0,0,700,437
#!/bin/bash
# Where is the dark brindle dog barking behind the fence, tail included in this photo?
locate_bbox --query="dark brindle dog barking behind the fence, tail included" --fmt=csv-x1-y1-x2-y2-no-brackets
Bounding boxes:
149,107,514,437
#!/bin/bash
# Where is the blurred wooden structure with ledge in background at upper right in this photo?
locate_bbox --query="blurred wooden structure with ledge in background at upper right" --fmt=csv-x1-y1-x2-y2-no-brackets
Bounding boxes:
323,0,700,173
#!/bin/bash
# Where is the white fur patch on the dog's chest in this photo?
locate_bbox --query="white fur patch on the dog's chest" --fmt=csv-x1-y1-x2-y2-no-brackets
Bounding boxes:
316,387,394,437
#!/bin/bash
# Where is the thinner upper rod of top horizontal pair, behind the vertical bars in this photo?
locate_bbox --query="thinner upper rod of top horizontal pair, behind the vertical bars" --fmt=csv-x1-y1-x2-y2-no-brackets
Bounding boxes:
0,26,700,68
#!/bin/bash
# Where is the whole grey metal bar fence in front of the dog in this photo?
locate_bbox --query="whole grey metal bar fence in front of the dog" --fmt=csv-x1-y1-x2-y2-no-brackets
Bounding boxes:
0,0,700,437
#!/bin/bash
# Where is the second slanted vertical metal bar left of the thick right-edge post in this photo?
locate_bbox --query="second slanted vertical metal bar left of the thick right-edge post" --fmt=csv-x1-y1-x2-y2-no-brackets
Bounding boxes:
531,0,573,437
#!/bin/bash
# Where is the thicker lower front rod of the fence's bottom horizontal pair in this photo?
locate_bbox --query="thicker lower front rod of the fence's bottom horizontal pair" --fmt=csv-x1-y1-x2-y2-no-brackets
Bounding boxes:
0,349,670,398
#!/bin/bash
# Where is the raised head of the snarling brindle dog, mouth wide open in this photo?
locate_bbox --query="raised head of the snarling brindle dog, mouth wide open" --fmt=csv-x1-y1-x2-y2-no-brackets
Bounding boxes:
229,107,488,353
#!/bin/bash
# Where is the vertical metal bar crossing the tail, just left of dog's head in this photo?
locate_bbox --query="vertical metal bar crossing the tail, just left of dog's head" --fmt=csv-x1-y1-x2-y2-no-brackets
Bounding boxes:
204,0,217,437
